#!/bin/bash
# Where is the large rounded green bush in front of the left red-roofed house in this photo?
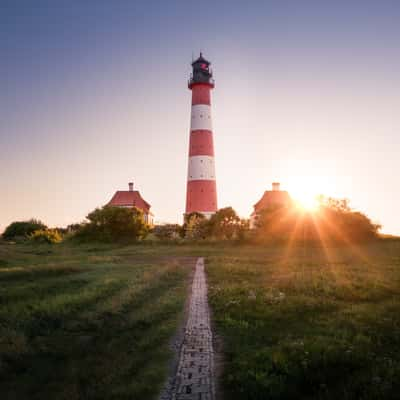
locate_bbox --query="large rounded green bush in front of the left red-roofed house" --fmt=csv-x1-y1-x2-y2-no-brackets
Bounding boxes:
77,206,149,242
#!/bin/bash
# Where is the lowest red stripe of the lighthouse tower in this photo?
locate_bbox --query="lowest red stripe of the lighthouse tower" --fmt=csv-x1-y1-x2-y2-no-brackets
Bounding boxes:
186,180,217,214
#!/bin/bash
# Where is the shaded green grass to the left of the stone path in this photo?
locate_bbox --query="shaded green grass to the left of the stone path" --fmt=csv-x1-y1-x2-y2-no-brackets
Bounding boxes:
0,244,194,400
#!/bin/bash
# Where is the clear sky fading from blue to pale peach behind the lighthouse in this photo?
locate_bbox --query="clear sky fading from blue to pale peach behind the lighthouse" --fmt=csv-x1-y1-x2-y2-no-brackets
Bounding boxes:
0,0,400,234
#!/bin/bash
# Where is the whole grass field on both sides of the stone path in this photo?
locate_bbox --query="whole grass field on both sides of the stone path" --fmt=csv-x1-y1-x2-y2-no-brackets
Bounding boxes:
0,240,400,400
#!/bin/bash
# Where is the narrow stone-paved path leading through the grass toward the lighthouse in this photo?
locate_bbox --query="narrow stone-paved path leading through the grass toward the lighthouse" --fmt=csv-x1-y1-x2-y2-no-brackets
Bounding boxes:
161,258,215,400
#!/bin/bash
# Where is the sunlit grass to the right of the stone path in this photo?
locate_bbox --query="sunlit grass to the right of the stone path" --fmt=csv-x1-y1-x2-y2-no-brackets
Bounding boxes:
207,241,400,400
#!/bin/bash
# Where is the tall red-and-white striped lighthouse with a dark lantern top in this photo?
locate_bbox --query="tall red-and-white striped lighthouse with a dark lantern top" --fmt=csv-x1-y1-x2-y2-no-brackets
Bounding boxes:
185,53,217,218
